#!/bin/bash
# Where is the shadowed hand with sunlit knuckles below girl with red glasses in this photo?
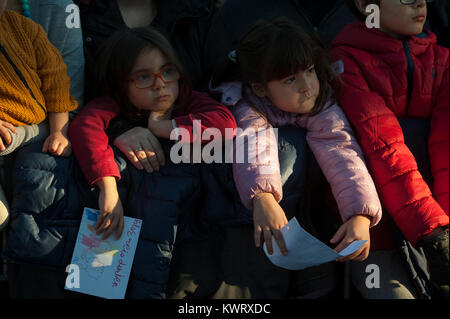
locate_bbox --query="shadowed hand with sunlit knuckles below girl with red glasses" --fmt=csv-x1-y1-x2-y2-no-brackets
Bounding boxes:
114,127,165,173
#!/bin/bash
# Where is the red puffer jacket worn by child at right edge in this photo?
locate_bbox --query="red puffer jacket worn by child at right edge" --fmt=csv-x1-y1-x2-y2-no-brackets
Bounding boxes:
330,22,449,248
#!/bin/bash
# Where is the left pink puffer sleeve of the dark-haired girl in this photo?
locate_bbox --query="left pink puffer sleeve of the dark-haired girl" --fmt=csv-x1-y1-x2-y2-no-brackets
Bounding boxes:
233,103,283,209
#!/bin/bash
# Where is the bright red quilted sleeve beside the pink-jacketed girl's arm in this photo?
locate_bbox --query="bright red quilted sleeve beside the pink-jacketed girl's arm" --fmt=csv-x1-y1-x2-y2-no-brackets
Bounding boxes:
331,49,448,244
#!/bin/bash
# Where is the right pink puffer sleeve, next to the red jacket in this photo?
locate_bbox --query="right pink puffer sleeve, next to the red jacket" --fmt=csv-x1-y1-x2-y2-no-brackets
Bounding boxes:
304,105,381,227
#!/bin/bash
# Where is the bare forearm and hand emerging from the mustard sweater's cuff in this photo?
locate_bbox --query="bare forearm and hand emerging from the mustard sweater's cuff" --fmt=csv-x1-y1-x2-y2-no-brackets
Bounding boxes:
42,112,72,156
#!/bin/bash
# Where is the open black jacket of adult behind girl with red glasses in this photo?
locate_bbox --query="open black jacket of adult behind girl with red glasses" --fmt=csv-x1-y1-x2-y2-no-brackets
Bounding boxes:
74,0,215,101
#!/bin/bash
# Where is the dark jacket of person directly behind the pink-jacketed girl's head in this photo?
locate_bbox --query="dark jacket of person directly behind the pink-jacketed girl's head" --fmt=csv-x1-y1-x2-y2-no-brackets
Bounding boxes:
205,0,356,79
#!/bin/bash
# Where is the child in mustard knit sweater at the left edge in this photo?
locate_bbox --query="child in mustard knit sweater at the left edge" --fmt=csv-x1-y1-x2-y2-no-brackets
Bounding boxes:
0,0,78,230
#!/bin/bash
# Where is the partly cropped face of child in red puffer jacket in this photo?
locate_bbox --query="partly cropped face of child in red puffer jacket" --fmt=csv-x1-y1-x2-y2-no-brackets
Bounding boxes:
380,0,427,38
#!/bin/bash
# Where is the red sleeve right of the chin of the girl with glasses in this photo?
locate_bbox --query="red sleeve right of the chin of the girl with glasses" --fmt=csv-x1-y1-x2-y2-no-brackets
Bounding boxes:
173,92,236,143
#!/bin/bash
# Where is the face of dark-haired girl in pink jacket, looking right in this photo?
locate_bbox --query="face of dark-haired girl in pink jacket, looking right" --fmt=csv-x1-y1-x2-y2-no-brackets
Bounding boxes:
258,65,320,114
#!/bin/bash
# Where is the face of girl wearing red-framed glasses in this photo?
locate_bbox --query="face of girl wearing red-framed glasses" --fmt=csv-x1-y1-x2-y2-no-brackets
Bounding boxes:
128,49,180,112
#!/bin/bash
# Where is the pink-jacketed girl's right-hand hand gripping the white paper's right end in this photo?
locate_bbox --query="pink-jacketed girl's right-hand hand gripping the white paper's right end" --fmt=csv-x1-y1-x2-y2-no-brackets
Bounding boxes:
330,215,370,261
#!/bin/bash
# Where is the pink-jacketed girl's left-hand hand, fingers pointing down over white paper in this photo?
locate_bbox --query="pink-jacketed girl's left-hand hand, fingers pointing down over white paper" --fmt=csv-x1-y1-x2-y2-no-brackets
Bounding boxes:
253,193,288,256
